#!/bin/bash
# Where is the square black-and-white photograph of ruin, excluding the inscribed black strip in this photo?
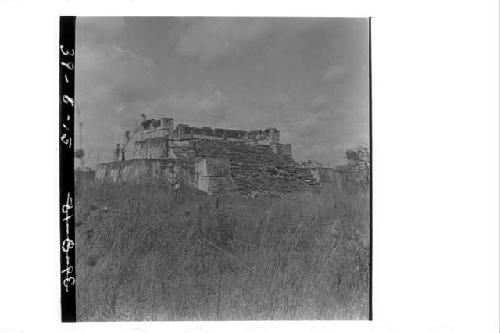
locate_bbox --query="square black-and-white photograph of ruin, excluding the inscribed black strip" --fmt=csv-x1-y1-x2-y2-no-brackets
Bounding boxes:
72,17,372,321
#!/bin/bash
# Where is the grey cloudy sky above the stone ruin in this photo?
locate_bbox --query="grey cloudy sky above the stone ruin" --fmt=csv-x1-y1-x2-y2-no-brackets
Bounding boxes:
75,17,369,165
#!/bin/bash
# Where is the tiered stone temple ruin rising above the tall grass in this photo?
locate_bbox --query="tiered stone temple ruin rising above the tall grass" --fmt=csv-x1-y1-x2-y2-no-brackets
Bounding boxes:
96,118,340,195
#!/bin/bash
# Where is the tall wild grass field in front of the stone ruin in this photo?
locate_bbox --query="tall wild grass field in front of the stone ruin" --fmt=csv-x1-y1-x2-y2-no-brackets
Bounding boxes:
75,182,370,321
